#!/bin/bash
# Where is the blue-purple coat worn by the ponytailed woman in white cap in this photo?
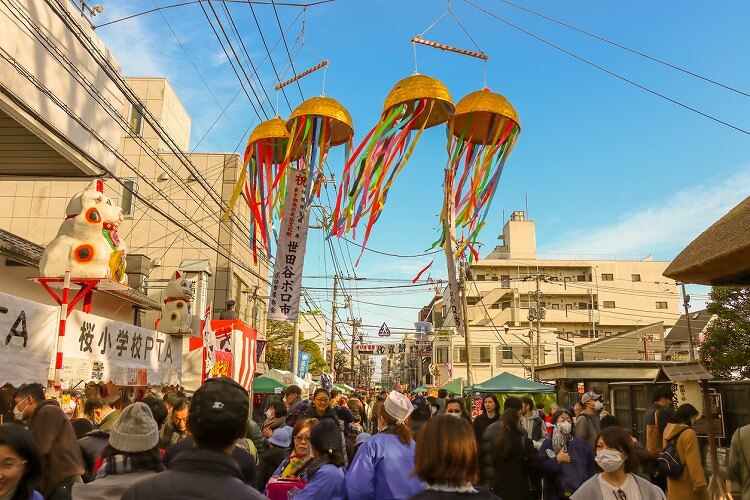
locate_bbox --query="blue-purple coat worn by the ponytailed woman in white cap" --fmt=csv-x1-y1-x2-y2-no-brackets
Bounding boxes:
346,430,424,500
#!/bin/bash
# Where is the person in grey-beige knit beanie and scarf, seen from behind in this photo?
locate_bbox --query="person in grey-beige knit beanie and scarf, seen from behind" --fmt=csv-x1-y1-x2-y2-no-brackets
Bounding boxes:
73,403,164,500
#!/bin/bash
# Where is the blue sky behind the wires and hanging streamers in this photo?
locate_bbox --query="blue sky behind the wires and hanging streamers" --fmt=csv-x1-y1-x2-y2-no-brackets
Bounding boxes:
96,0,750,348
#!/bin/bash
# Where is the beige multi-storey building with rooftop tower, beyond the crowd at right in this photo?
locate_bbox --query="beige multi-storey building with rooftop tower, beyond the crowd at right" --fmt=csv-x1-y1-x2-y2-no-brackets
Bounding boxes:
419,212,679,382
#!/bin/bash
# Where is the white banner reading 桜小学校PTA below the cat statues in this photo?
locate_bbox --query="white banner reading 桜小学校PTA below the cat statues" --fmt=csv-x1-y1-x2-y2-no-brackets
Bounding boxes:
62,311,182,387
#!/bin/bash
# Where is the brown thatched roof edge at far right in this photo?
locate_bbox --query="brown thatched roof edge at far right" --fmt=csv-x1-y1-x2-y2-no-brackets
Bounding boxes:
664,197,750,286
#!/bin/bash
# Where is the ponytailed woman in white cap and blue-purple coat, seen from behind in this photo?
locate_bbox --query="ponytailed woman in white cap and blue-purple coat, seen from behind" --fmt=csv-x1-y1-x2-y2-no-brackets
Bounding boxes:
346,391,424,500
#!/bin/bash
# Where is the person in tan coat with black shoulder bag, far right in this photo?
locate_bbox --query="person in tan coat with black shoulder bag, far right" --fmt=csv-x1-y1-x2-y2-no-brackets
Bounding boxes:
663,403,708,500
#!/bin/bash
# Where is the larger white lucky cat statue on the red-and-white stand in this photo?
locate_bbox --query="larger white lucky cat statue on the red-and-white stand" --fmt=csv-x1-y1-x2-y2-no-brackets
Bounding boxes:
39,179,128,284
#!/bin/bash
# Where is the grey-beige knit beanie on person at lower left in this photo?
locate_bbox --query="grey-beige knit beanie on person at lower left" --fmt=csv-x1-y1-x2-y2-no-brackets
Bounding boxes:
109,403,159,453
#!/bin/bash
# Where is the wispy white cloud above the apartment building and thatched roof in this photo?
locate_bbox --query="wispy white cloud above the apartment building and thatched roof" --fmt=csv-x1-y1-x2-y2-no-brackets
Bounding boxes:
539,167,750,258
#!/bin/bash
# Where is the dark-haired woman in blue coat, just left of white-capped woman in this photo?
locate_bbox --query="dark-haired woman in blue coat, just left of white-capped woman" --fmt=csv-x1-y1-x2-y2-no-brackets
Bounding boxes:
294,419,346,500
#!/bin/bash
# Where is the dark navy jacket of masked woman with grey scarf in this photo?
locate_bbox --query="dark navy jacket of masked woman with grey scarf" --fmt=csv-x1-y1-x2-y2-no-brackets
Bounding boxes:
539,437,598,500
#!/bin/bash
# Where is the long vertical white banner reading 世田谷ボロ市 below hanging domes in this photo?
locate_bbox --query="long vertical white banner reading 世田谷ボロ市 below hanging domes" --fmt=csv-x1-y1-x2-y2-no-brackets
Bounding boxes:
268,169,310,323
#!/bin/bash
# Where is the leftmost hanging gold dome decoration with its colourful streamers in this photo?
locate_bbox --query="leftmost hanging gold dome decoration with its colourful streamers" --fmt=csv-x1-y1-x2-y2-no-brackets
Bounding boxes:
224,116,302,262
